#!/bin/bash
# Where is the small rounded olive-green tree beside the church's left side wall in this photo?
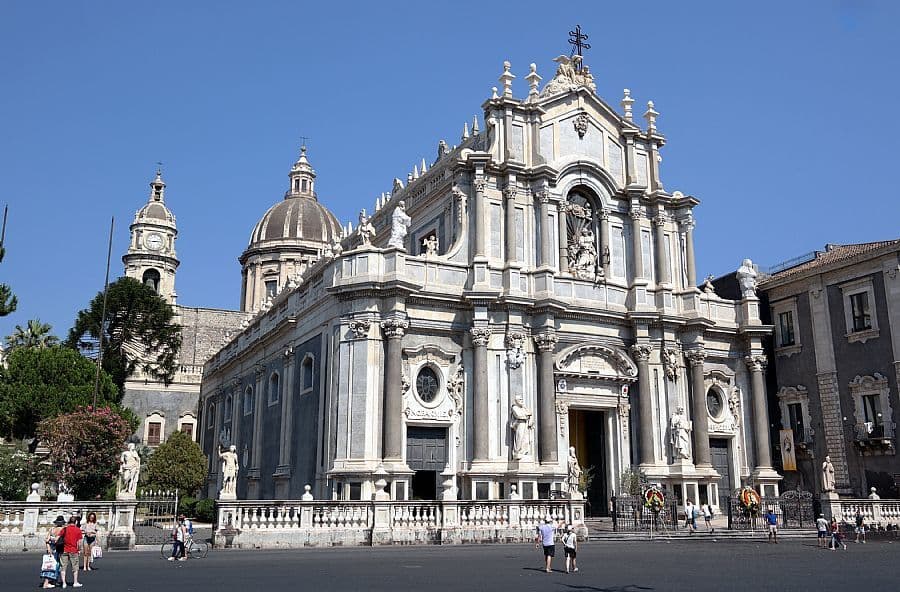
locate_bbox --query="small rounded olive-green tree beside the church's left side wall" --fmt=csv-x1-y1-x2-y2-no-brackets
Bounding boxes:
147,432,206,496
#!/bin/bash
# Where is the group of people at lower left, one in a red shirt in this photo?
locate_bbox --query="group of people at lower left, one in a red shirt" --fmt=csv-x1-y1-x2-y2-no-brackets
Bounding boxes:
41,512,100,588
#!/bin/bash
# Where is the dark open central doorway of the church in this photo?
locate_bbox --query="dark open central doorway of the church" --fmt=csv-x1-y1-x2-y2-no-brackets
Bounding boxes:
569,409,609,516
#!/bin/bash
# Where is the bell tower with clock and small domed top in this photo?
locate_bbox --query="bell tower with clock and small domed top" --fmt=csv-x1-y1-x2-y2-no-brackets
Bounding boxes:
122,169,179,305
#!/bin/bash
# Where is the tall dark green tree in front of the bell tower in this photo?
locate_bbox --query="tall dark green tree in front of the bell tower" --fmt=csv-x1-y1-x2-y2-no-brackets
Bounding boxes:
66,277,181,389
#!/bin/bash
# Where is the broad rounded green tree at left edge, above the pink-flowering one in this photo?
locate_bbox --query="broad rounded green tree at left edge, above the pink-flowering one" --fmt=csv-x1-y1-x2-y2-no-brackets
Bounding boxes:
0,346,120,438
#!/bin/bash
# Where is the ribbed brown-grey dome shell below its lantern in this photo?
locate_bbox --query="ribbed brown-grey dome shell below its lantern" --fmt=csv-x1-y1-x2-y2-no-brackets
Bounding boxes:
248,197,341,249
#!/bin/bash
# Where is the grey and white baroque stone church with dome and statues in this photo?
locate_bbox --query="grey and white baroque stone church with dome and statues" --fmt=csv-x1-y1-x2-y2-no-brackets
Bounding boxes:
200,56,780,514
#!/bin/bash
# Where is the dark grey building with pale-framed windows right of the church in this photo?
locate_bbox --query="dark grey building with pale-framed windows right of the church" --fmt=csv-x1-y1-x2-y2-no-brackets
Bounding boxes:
759,239,900,498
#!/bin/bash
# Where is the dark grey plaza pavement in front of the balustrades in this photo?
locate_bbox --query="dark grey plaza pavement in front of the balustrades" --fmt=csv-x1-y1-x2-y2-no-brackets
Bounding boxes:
0,539,900,592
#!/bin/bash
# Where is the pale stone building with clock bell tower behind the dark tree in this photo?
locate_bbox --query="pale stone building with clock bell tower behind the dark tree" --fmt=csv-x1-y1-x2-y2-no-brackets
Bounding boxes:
122,171,249,447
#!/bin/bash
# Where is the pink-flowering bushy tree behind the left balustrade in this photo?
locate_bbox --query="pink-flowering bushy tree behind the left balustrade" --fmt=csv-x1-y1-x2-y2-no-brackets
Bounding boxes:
38,407,134,500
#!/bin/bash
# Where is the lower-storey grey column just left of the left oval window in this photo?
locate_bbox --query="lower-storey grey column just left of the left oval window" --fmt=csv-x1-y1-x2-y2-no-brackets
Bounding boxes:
381,319,409,462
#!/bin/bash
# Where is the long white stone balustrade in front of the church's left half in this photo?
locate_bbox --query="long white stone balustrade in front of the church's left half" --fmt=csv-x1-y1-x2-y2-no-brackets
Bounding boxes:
215,500,584,548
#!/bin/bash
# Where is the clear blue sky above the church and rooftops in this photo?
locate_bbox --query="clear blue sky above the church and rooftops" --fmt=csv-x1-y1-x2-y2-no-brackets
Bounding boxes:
0,0,900,335
